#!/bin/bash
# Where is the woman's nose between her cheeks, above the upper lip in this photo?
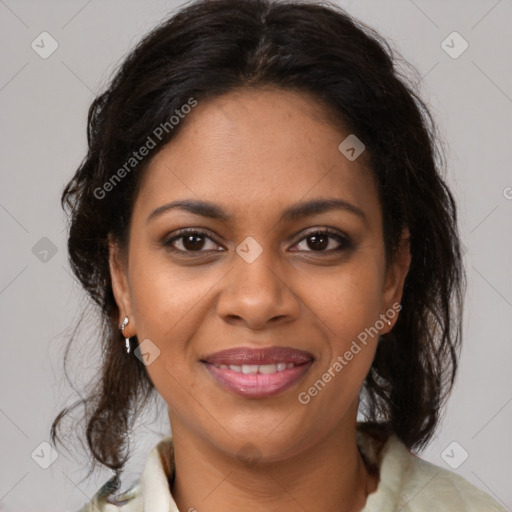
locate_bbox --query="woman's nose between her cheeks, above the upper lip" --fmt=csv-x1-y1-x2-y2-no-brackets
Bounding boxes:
217,251,301,330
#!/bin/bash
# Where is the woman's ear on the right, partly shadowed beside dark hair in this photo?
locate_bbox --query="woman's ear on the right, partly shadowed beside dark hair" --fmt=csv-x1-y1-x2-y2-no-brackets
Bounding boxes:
381,228,411,334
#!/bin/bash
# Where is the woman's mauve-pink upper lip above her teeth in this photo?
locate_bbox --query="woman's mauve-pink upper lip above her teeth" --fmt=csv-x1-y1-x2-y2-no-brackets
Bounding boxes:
202,347,314,365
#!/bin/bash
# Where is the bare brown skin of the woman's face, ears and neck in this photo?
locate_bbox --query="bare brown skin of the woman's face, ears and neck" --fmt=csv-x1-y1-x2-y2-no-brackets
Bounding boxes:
110,89,410,512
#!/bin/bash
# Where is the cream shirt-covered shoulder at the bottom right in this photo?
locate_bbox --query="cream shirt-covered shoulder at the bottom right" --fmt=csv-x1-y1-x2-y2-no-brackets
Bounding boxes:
364,435,505,512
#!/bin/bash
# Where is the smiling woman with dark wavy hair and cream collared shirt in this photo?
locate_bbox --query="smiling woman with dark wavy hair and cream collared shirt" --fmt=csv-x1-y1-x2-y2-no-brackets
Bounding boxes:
52,0,503,512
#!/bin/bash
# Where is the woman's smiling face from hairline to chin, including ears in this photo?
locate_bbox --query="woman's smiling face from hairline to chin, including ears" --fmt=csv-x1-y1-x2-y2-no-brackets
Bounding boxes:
111,86,409,460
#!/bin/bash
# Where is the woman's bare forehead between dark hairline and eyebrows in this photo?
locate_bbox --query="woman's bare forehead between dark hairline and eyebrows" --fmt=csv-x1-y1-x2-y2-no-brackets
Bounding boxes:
132,89,379,228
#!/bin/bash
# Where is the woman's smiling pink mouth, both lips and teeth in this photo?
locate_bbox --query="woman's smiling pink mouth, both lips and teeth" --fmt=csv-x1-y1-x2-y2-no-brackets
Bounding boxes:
201,347,314,398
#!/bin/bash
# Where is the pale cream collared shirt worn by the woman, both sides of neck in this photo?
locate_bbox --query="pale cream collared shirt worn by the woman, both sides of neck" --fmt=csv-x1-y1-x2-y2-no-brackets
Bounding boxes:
79,424,505,512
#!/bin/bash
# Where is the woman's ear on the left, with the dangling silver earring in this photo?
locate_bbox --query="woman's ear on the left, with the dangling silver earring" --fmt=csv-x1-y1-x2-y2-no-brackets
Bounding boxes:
108,237,136,337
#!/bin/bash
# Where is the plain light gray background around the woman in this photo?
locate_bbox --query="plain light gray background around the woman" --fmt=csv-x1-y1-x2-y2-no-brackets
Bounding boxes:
0,0,512,512
